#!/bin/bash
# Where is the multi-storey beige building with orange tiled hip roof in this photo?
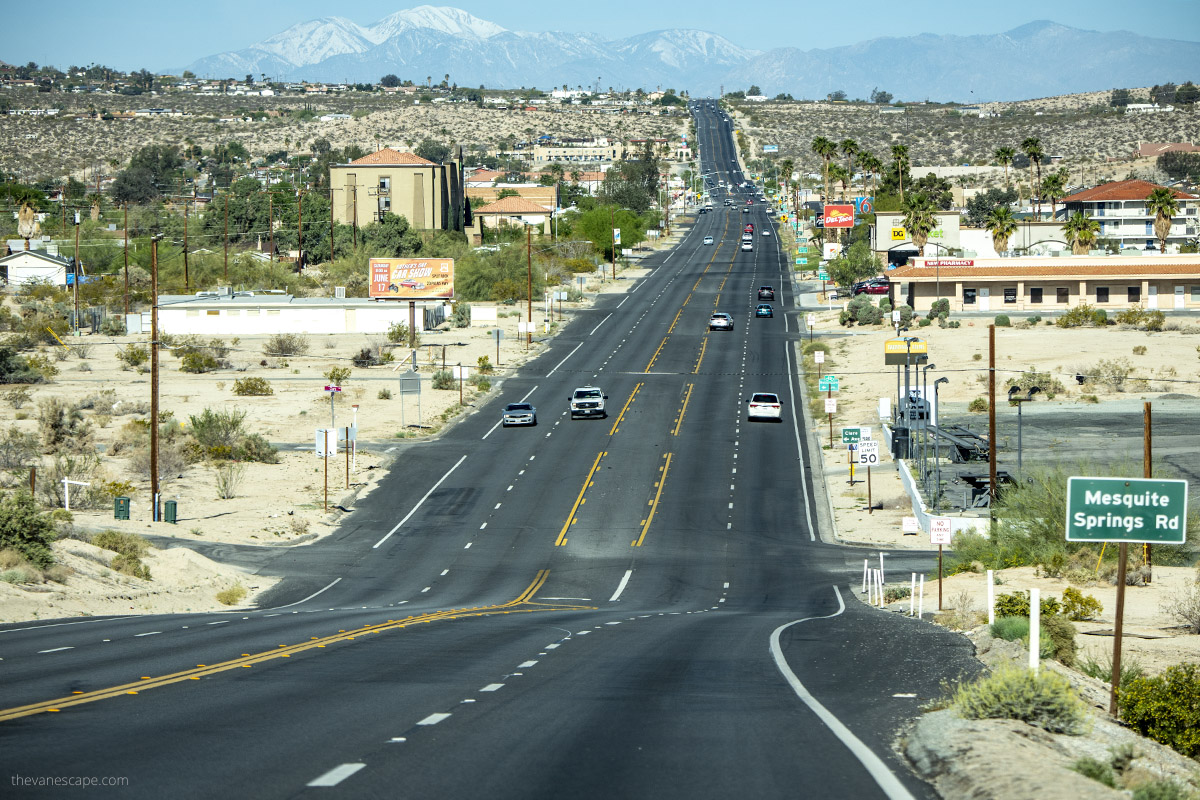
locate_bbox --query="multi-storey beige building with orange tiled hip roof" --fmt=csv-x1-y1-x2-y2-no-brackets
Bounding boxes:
329,148,470,230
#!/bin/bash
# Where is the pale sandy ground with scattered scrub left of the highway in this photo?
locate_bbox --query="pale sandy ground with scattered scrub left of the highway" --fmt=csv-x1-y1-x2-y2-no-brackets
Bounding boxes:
0,248,668,621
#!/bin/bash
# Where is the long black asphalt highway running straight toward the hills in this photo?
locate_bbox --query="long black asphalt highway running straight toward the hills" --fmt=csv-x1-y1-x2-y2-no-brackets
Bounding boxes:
0,102,978,798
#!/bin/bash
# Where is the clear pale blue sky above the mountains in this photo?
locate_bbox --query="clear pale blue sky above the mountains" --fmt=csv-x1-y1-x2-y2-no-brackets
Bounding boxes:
7,0,1200,72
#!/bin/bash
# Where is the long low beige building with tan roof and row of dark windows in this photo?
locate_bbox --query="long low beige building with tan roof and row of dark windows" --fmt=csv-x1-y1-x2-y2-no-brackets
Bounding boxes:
887,254,1200,313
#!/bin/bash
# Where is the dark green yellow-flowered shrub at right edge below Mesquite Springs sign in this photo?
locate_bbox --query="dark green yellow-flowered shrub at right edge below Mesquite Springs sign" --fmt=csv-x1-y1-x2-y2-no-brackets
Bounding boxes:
1118,663,1200,758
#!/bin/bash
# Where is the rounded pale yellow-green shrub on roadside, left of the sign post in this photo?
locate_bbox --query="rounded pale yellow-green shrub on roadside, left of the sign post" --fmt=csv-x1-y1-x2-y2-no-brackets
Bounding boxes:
952,664,1087,735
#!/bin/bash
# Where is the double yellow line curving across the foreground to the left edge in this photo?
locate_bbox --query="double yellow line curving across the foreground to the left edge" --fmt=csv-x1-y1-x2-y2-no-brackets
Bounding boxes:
0,570,594,722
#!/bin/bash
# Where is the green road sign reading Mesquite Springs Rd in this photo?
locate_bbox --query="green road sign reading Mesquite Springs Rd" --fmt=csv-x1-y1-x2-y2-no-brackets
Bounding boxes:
1067,477,1188,545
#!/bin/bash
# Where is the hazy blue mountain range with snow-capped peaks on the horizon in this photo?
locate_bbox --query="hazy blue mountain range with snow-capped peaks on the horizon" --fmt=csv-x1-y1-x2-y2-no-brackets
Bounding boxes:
186,6,1200,102
